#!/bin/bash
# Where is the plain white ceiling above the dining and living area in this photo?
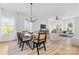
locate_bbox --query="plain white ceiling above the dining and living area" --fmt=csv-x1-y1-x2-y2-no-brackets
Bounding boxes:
0,3,79,18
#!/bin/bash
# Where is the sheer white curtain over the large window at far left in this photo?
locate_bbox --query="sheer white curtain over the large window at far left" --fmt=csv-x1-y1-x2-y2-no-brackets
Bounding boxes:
1,16,15,41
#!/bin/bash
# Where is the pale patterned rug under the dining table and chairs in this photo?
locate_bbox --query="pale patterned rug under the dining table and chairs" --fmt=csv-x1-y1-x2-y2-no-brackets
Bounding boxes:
8,40,62,55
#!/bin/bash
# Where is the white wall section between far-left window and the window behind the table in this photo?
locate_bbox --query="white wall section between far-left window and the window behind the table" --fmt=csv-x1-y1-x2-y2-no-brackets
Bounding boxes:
15,14,25,32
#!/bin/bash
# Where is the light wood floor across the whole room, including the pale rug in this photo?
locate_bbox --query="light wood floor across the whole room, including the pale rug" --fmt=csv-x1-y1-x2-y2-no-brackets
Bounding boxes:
0,40,79,55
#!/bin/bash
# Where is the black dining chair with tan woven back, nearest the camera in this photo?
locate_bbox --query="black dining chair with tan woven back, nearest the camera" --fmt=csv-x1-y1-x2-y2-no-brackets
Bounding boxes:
33,32,47,55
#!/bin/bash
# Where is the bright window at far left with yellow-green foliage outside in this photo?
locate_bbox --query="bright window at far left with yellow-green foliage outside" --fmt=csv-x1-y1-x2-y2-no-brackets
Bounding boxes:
1,17,14,34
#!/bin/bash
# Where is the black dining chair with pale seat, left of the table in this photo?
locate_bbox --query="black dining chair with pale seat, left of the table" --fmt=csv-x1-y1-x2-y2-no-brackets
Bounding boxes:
17,33,31,51
